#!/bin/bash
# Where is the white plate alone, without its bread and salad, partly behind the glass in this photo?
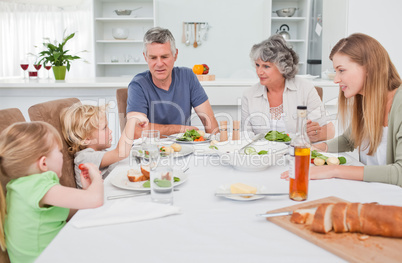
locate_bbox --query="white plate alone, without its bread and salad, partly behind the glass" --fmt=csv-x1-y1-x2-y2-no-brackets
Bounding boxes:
109,166,188,191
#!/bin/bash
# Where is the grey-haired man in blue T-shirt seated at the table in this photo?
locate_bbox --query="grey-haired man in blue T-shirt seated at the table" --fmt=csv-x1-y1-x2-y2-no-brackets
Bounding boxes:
127,27,218,138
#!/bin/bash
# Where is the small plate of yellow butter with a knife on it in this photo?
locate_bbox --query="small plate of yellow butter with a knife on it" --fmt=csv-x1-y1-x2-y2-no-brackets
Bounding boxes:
216,183,267,201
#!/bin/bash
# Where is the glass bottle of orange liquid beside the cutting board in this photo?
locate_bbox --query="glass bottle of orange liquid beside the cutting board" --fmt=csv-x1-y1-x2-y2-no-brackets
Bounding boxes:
289,106,311,201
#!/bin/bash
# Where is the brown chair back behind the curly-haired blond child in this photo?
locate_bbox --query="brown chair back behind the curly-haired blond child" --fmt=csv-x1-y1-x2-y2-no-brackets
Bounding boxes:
28,98,80,188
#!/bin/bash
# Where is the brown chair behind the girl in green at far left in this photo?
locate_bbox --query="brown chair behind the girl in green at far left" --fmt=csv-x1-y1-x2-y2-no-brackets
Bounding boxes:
0,108,25,263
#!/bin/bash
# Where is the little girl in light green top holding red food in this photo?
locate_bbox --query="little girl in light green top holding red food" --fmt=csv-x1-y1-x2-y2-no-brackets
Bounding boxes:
0,122,104,262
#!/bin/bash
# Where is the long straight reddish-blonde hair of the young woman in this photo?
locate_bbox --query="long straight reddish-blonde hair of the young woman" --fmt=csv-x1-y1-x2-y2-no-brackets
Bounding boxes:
329,33,402,155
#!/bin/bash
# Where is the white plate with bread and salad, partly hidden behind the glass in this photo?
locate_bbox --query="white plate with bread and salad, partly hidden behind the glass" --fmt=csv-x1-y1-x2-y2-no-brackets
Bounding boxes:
109,166,188,191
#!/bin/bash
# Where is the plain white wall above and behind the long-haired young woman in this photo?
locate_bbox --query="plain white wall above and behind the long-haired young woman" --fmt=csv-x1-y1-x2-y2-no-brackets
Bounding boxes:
347,0,402,74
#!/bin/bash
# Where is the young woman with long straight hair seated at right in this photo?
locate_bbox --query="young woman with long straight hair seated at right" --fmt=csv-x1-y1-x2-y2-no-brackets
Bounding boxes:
282,34,402,186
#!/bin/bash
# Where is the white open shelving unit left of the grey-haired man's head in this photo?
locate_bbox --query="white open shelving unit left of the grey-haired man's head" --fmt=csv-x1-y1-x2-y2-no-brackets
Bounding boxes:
93,0,156,77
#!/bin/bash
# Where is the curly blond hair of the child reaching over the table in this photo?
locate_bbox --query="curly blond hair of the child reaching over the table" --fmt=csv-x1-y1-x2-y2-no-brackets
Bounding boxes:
61,103,107,154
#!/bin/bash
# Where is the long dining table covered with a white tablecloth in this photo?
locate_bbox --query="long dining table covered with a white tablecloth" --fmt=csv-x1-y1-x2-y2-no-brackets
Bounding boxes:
36,143,402,263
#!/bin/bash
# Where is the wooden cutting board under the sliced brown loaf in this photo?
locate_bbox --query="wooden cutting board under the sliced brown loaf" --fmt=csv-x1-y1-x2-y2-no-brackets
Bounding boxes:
267,196,402,263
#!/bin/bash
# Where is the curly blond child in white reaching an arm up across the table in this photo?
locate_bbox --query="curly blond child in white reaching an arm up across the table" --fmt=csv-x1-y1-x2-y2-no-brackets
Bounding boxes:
61,103,148,187
